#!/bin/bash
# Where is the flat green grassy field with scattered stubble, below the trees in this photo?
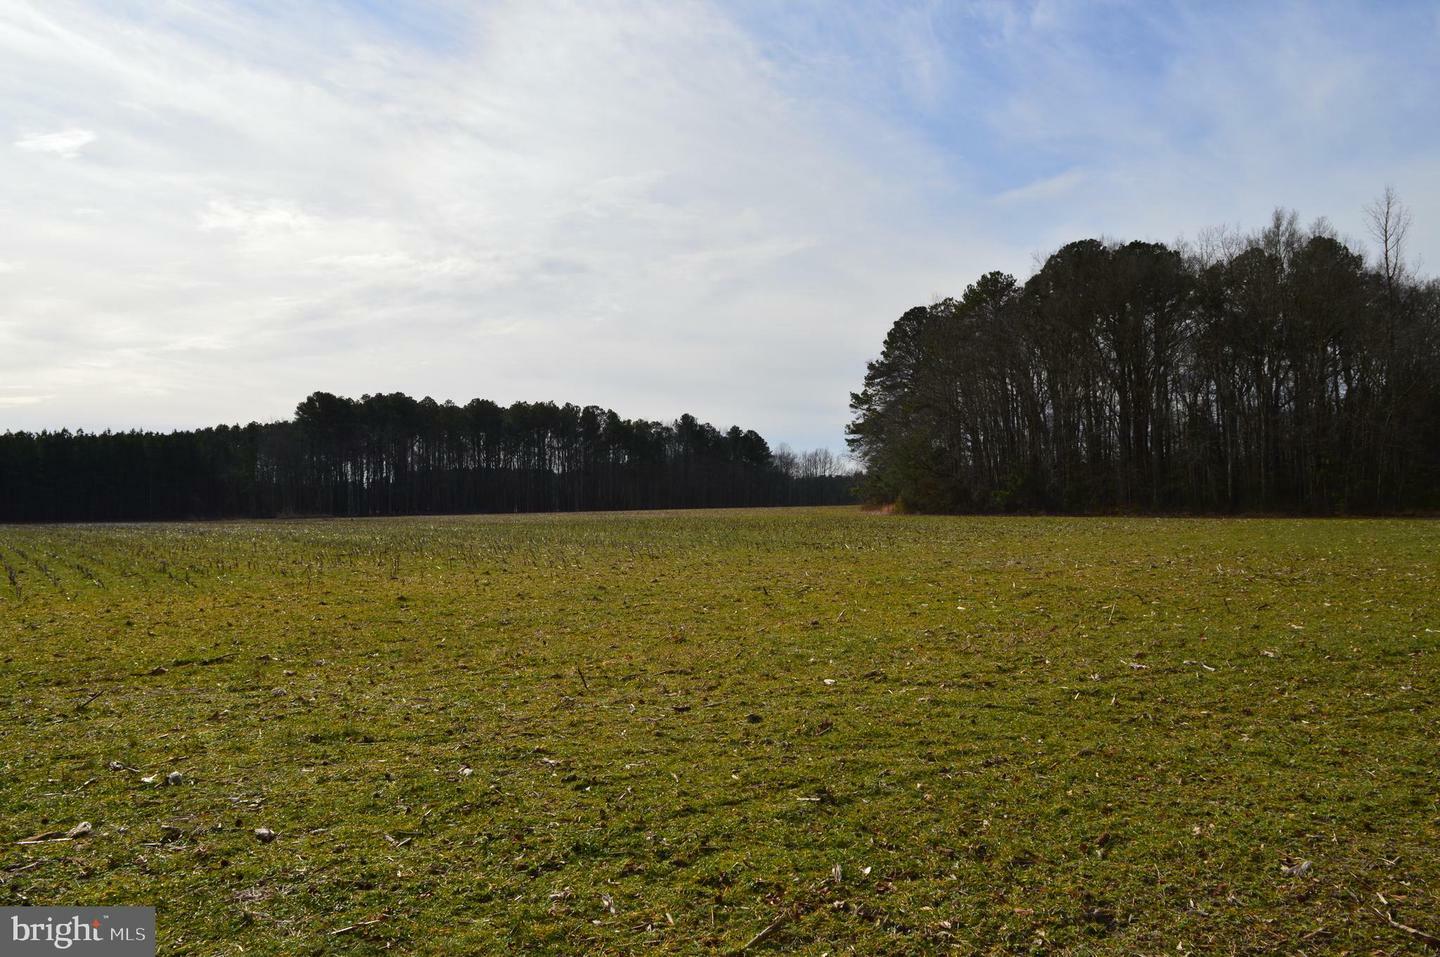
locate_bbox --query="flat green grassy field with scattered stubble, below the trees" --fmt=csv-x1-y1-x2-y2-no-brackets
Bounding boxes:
0,509,1440,954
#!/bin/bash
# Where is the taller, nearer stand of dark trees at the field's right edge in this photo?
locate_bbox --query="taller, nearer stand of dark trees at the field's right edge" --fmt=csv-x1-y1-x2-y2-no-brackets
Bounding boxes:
848,190,1440,514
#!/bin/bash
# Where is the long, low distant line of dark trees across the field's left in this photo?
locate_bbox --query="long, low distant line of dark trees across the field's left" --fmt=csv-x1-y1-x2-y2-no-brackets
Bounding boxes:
0,391,854,522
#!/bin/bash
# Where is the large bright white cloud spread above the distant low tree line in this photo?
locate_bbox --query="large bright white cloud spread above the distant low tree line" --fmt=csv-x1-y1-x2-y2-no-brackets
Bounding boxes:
0,0,963,445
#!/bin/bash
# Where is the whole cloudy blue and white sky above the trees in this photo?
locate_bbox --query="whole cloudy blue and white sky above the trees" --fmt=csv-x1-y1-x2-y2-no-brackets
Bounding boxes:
0,0,1440,450
